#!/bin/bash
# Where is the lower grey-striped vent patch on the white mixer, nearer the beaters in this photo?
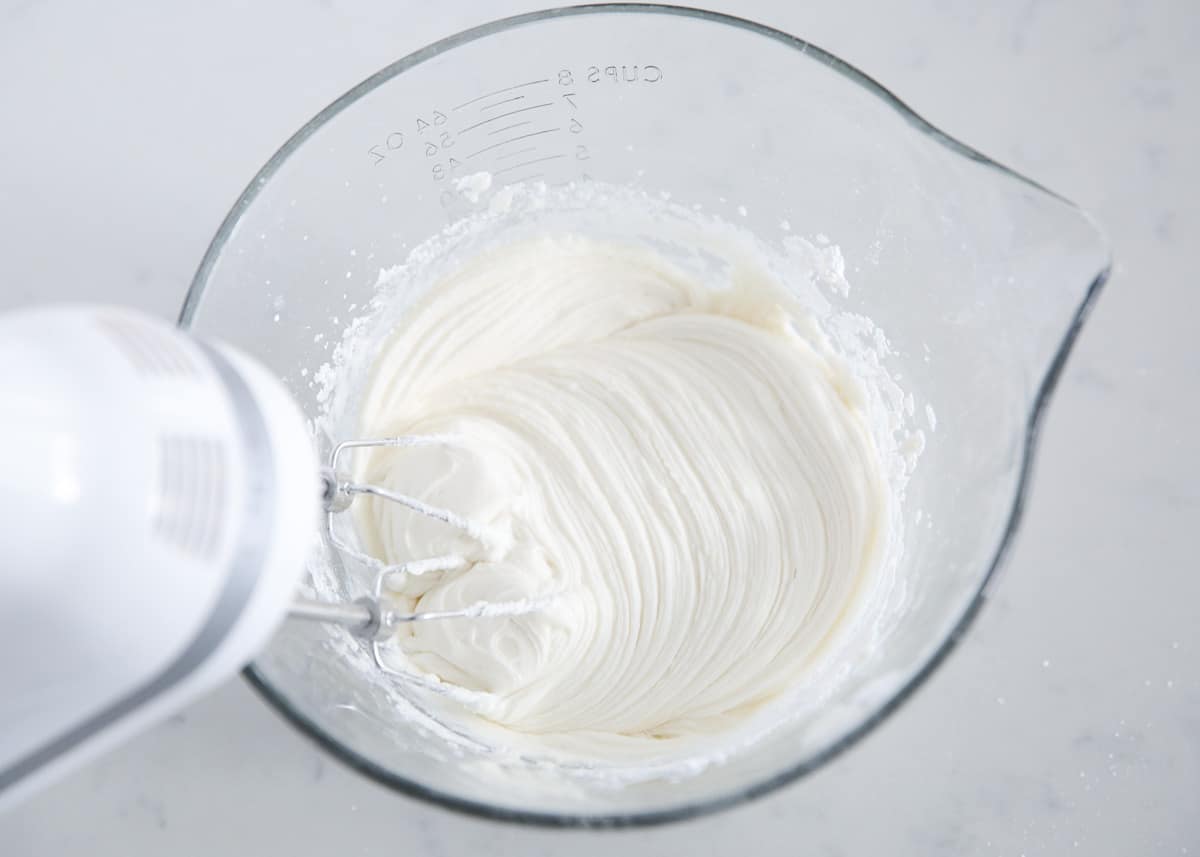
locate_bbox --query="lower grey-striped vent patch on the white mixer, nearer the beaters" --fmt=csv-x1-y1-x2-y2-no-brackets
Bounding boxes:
154,435,228,559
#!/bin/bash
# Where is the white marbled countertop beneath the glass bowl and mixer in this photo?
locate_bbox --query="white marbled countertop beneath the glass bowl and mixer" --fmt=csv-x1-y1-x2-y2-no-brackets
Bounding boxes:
0,0,1200,857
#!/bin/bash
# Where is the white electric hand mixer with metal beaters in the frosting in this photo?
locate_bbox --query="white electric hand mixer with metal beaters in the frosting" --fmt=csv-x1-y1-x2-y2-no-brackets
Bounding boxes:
0,306,496,807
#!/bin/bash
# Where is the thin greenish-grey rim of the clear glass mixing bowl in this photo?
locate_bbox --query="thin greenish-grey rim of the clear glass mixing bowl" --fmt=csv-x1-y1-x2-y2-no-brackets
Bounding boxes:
179,4,1111,828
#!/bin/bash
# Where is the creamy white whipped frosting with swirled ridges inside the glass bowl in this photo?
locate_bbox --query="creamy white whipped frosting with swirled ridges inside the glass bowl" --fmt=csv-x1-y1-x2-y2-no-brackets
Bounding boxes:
355,236,888,757
